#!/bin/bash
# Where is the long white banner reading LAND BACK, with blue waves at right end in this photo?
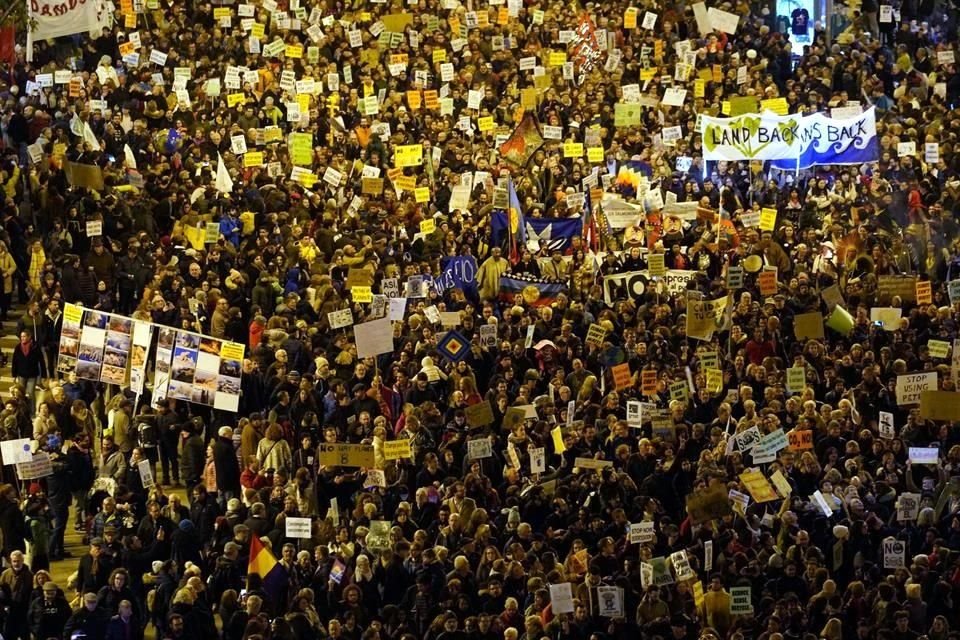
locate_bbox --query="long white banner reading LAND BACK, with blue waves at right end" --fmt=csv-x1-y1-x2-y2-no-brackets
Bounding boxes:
702,107,880,169
